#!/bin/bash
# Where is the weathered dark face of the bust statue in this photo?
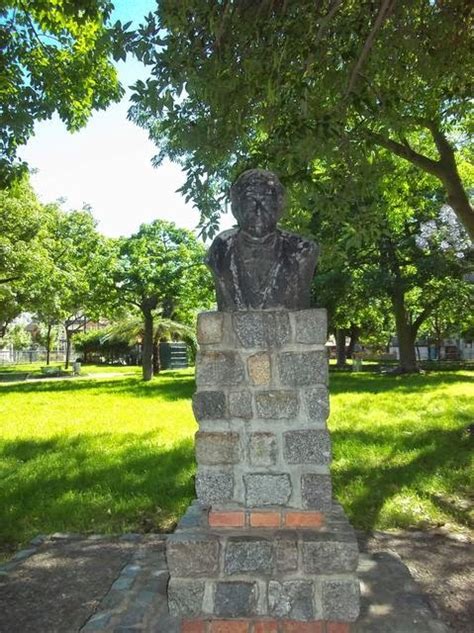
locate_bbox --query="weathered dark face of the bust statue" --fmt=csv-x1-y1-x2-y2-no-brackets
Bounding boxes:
238,178,280,237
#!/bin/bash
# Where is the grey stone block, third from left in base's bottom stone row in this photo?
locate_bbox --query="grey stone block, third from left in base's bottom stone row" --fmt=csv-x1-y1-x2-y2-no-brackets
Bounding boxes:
268,580,314,621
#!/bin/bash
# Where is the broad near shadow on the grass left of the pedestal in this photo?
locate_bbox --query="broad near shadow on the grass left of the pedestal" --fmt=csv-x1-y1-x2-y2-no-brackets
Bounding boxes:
0,433,195,549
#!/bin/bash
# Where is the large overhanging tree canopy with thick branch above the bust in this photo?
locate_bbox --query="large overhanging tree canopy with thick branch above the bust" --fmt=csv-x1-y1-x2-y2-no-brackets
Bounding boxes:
130,0,474,238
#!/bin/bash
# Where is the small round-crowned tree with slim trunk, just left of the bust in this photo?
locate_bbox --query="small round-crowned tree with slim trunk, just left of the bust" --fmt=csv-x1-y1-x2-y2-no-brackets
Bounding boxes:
113,220,211,380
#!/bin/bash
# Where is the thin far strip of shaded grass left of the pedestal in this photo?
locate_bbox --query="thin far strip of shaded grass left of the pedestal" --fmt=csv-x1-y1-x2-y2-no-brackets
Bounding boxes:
0,372,195,400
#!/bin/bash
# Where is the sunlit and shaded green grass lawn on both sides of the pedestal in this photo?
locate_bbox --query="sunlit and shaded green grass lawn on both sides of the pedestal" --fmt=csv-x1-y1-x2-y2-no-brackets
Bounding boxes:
0,366,474,551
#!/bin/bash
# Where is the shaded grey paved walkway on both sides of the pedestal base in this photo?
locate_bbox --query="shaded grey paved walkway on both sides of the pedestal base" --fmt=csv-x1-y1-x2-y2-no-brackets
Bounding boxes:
0,534,456,633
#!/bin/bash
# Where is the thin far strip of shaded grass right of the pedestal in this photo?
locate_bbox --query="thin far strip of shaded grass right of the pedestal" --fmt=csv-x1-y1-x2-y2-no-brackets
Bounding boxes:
329,372,474,395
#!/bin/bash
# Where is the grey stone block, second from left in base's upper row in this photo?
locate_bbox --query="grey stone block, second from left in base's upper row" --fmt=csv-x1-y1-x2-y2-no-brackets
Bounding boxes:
224,536,273,575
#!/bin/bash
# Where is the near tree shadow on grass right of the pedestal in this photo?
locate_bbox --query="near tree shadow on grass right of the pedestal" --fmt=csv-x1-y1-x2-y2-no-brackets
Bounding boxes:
332,428,472,530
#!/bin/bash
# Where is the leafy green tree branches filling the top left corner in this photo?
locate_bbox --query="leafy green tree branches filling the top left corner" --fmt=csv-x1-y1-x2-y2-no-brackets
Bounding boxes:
0,0,130,187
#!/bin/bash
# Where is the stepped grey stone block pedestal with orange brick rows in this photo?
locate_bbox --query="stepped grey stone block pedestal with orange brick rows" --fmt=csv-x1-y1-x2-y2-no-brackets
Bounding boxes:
167,310,359,633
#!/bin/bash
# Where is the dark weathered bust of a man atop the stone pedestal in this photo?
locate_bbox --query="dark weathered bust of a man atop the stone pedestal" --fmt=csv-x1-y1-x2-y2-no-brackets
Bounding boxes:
207,169,317,311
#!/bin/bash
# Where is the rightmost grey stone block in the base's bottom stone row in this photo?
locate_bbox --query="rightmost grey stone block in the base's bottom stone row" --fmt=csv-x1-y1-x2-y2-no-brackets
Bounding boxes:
321,577,360,622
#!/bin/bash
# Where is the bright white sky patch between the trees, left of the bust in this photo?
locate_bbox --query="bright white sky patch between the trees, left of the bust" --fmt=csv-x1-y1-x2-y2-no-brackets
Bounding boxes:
19,0,234,237
